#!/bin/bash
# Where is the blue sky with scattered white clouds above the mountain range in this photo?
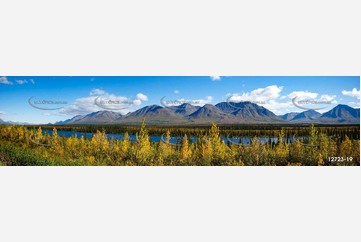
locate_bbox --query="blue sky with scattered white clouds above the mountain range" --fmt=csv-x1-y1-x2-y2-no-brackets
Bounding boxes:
0,76,360,123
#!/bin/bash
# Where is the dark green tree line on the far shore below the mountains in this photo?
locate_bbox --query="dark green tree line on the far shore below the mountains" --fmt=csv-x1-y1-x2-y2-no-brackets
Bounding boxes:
26,124,360,141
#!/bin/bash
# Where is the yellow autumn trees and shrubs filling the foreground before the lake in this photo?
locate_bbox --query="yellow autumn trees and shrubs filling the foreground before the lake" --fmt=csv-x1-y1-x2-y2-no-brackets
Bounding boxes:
0,121,360,166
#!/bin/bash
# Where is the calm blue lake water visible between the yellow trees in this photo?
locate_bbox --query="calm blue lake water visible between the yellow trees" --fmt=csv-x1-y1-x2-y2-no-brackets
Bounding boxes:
43,129,294,144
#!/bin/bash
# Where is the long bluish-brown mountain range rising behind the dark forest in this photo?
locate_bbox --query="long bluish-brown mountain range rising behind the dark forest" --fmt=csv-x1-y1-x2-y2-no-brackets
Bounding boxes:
55,102,360,125
